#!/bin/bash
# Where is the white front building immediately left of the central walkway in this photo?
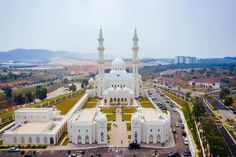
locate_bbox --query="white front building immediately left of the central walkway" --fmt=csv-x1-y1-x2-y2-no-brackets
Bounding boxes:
67,108,107,144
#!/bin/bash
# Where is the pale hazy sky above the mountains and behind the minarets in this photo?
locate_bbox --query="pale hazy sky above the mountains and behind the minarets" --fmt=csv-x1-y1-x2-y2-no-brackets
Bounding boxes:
0,0,236,58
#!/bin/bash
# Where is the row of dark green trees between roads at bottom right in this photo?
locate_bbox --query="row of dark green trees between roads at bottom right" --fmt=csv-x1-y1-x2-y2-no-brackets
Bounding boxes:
192,99,229,157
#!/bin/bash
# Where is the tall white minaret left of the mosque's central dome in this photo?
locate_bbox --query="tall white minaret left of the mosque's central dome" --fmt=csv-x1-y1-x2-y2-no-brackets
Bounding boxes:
98,28,105,76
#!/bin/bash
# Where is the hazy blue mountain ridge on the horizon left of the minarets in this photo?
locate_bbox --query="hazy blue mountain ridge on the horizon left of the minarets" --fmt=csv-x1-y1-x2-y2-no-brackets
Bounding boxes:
0,49,112,61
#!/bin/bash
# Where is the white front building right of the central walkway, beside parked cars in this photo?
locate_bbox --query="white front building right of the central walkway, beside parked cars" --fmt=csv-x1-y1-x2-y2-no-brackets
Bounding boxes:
131,108,172,144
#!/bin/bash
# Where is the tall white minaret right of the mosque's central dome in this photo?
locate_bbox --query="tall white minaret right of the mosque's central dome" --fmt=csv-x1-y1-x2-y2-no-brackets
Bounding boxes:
132,28,139,75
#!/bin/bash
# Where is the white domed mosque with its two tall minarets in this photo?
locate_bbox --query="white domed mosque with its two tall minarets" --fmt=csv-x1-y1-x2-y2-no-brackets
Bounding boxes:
94,29,143,105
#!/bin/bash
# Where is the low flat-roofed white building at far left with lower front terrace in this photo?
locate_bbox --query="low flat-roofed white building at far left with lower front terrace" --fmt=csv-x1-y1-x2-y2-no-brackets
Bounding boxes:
3,108,66,145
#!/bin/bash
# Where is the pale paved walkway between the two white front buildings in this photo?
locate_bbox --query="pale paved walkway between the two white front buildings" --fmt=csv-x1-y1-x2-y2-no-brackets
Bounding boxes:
110,108,128,147
